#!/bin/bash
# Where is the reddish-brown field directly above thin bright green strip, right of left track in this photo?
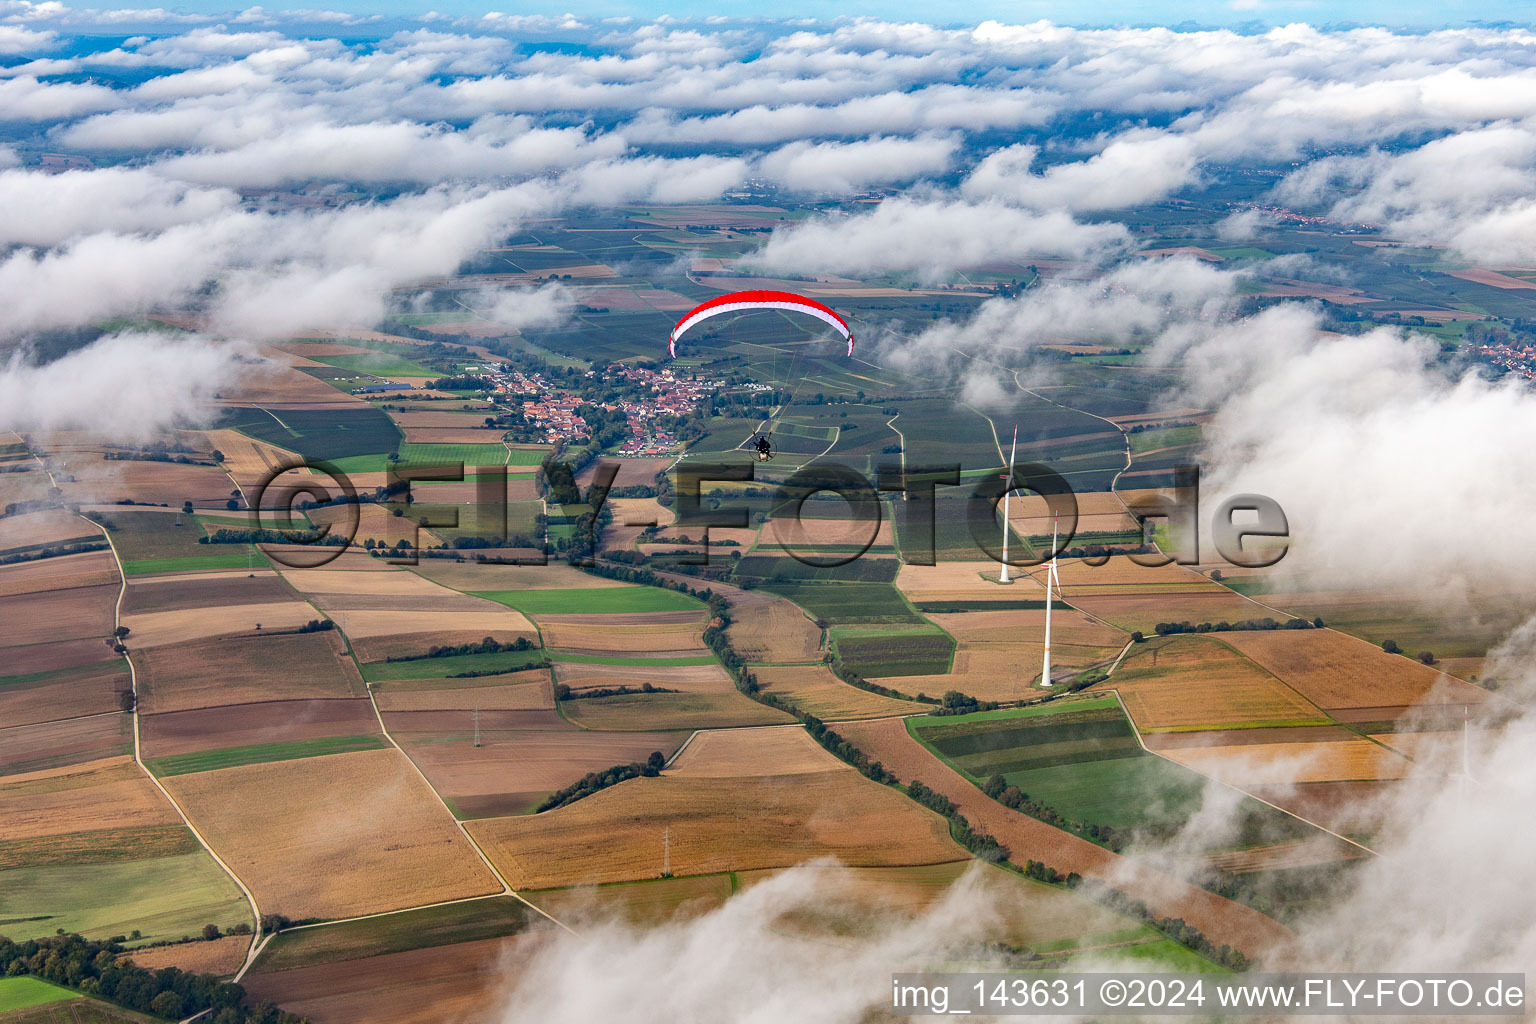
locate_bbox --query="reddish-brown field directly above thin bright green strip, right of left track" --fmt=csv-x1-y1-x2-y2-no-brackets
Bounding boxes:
138,699,379,758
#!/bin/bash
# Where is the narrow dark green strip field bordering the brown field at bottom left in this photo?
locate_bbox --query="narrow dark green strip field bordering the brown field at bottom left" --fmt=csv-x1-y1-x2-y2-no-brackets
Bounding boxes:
252,897,542,975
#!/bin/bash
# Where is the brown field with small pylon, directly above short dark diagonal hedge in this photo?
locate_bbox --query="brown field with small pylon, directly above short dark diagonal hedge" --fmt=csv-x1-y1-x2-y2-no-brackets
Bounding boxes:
384,709,688,818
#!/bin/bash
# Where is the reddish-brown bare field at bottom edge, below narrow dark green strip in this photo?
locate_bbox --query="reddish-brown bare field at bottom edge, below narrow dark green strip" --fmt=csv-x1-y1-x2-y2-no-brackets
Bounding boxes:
244,936,530,1024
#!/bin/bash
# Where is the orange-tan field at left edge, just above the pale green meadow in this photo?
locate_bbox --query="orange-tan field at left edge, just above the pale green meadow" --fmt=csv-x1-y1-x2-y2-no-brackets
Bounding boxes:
0,755,181,841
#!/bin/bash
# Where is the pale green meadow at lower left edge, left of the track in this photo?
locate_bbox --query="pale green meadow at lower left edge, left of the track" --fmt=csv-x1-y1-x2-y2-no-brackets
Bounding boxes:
0,851,255,941
